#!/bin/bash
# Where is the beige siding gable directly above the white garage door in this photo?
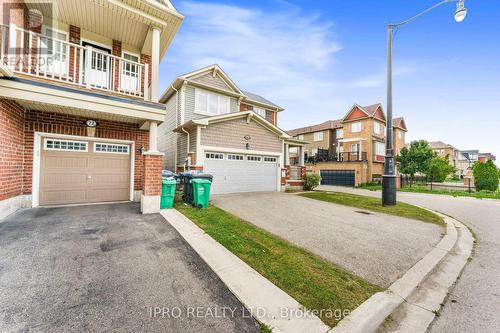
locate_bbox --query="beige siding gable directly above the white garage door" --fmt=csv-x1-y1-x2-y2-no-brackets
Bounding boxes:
201,118,282,153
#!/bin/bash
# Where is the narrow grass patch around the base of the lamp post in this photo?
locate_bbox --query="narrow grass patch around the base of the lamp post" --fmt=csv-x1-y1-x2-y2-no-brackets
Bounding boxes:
299,191,446,227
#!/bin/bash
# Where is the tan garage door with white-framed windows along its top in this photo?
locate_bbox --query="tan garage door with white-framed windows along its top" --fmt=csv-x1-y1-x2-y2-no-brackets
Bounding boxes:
39,138,131,205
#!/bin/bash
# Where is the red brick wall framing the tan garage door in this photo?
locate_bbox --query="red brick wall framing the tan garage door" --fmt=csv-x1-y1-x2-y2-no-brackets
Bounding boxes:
23,110,149,194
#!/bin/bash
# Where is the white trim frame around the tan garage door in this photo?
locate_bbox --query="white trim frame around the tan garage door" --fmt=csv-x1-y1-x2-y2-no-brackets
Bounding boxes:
31,132,135,207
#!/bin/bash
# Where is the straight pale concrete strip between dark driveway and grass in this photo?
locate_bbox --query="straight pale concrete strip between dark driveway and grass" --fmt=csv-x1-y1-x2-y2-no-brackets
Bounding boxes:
160,209,330,333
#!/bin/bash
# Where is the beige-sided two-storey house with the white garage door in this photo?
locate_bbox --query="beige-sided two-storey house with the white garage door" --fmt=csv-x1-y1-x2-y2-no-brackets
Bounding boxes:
158,65,305,193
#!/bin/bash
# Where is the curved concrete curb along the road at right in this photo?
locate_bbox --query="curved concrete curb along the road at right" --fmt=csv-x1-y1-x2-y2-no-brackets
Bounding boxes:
329,212,472,333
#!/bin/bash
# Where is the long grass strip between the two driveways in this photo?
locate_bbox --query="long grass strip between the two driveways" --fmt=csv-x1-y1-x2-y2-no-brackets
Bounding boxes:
175,203,382,327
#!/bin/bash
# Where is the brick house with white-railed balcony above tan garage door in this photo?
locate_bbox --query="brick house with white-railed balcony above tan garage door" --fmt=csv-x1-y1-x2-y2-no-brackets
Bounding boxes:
0,0,183,216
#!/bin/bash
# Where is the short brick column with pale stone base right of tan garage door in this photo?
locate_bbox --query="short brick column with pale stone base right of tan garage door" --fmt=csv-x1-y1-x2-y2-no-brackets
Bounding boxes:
141,153,163,214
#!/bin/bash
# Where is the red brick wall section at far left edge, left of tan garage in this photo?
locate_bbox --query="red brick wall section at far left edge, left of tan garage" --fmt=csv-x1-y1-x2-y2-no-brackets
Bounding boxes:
0,99,24,200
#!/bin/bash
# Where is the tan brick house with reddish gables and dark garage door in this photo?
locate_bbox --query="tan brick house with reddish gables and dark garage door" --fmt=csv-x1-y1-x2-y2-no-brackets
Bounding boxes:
288,104,408,186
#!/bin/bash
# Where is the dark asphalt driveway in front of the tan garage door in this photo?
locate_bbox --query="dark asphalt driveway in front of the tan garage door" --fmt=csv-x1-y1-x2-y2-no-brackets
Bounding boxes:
0,204,260,332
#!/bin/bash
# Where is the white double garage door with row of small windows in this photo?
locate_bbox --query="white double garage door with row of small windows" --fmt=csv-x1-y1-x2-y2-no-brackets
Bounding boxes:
204,152,279,194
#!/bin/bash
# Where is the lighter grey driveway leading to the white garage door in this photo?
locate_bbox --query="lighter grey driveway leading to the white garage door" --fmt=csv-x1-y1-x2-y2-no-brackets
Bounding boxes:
214,192,444,287
